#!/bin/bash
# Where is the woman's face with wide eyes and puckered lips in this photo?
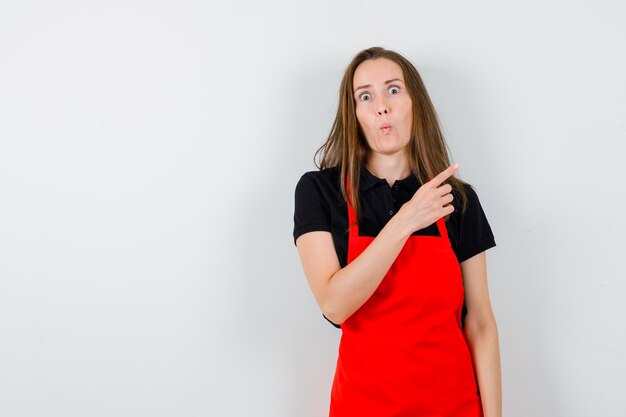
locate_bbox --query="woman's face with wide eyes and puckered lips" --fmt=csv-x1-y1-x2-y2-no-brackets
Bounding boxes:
352,58,413,155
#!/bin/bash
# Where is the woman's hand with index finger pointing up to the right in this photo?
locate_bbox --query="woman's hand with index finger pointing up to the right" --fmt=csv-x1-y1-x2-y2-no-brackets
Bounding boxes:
398,164,459,234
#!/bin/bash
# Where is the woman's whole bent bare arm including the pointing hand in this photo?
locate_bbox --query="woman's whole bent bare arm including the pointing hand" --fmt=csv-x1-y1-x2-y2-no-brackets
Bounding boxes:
296,164,458,324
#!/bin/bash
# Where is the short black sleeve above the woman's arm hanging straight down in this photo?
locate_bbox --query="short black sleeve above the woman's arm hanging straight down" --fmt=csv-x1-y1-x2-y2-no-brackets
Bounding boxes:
455,184,496,263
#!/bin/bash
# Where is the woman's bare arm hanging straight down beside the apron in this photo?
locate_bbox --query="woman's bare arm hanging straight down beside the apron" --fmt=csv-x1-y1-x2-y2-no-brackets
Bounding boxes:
461,251,502,417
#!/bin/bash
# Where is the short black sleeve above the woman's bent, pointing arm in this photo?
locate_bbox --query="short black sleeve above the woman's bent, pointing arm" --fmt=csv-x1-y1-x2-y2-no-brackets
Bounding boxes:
293,174,331,245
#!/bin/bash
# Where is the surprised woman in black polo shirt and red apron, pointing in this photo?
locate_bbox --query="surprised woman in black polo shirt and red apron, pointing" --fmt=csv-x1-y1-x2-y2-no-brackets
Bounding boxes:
294,47,502,417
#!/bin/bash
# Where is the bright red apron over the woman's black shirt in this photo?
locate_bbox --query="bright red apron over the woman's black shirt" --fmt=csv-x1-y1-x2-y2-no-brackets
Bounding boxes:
329,174,483,417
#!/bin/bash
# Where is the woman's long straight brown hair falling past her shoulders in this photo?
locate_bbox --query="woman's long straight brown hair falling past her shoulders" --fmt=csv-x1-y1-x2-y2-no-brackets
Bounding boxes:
313,47,467,228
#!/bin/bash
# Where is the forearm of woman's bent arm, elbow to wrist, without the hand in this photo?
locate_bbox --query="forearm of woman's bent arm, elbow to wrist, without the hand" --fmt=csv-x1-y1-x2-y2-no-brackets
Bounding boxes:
324,211,410,324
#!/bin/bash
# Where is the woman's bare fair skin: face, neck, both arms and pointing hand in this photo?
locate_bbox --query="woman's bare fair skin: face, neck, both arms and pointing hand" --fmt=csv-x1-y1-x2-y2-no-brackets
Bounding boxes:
296,58,502,417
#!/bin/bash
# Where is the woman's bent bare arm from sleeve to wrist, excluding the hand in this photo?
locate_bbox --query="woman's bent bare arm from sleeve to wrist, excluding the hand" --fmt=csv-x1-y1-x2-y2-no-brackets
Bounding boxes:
296,211,411,324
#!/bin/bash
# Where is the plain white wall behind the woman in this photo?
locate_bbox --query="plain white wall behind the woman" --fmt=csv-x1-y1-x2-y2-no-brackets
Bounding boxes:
0,0,626,417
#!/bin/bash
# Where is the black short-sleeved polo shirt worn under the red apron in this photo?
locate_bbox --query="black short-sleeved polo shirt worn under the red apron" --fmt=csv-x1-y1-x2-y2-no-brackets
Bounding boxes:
293,165,496,328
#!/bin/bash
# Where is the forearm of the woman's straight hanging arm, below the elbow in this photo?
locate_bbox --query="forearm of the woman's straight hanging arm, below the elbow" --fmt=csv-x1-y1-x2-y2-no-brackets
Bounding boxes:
464,320,502,417
